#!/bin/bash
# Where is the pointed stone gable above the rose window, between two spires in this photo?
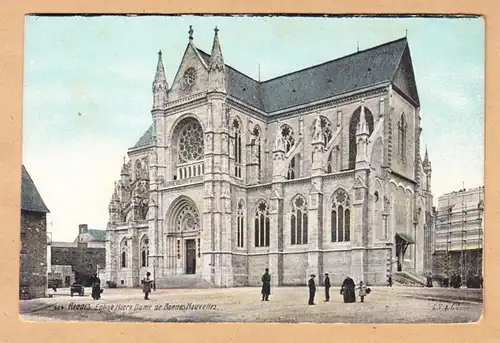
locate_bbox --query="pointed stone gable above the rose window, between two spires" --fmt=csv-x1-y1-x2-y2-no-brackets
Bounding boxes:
168,43,208,101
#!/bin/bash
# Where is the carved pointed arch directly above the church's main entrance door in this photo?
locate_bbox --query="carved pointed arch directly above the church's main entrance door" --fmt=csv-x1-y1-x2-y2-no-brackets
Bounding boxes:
167,195,202,232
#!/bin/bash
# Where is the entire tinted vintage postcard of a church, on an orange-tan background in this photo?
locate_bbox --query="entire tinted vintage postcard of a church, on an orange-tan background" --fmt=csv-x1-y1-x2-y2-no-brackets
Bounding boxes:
19,15,485,323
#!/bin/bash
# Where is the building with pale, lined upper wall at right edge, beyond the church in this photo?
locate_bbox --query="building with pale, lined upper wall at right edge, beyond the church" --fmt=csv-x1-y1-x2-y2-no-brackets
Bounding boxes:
432,186,484,280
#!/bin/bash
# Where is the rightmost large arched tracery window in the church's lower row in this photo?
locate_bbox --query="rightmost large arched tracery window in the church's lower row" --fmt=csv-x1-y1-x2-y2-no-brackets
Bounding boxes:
330,189,351,242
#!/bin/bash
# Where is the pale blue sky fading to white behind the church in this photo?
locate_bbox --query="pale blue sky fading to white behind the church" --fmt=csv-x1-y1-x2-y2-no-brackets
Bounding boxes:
23,16,485,240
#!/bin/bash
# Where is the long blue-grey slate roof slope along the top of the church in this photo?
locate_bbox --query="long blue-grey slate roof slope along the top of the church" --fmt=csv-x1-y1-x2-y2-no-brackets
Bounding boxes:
198,38,412,113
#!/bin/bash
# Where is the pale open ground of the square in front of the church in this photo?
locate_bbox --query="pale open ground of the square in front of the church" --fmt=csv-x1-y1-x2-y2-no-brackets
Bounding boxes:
20,287,483,324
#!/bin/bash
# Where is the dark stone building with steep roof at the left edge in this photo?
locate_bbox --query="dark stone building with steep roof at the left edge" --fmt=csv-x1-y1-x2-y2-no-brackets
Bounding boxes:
19,165,49,299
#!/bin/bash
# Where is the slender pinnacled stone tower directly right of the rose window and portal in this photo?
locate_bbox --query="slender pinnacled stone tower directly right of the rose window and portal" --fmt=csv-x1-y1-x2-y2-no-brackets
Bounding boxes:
202,27,233,287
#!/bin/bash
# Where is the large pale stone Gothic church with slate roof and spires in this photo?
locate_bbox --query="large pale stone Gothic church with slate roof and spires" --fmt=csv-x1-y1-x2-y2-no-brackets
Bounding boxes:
103,28,434,287
